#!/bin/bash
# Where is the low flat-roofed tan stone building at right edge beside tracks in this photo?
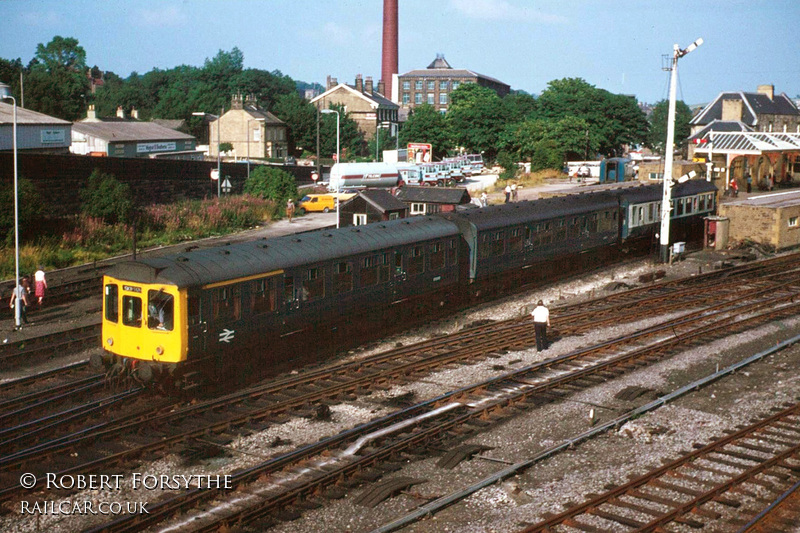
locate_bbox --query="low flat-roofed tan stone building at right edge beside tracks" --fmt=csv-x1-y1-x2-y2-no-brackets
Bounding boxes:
719,191,800,250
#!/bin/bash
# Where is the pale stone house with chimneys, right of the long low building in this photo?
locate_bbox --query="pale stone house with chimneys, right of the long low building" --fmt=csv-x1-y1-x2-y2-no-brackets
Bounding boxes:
208,94,289,159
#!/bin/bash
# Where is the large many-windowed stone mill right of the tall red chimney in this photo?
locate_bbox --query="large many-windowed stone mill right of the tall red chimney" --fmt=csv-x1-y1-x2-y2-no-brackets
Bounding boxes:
392,54,511,113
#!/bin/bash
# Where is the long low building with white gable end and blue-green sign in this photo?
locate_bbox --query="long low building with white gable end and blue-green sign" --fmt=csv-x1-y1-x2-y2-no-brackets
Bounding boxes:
70,105,202,159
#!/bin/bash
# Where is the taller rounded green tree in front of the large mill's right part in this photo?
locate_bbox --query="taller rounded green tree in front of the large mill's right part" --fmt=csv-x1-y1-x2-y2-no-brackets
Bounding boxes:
446,83,505,159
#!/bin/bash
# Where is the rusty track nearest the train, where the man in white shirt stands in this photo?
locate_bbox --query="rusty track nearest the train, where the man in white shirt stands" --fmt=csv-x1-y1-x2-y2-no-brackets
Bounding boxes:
0,260,800,484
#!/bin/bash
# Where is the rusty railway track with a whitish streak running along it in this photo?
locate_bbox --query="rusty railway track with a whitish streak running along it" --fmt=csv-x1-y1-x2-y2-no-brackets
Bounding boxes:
86,280,800,532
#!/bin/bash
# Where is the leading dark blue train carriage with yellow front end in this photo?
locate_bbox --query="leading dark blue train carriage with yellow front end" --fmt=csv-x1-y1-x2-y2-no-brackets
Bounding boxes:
103,217,463,379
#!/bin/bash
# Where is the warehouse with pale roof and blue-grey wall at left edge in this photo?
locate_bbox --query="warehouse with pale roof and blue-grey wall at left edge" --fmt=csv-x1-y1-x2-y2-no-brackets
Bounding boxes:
0,102,72,154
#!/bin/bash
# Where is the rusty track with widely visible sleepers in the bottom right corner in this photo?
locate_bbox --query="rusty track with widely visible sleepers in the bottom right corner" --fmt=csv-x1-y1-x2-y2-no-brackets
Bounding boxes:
524,404,800,533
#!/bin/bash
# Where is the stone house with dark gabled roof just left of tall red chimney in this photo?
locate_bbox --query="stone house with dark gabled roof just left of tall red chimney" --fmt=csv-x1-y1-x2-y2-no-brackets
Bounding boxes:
311,74,398,138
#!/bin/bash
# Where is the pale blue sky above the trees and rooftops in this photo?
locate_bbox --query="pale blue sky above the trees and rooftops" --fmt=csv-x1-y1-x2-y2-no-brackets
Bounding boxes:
0,0,800,104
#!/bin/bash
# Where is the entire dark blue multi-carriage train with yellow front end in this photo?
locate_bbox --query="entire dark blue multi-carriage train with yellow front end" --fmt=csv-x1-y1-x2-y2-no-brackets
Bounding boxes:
100,180,716,384
